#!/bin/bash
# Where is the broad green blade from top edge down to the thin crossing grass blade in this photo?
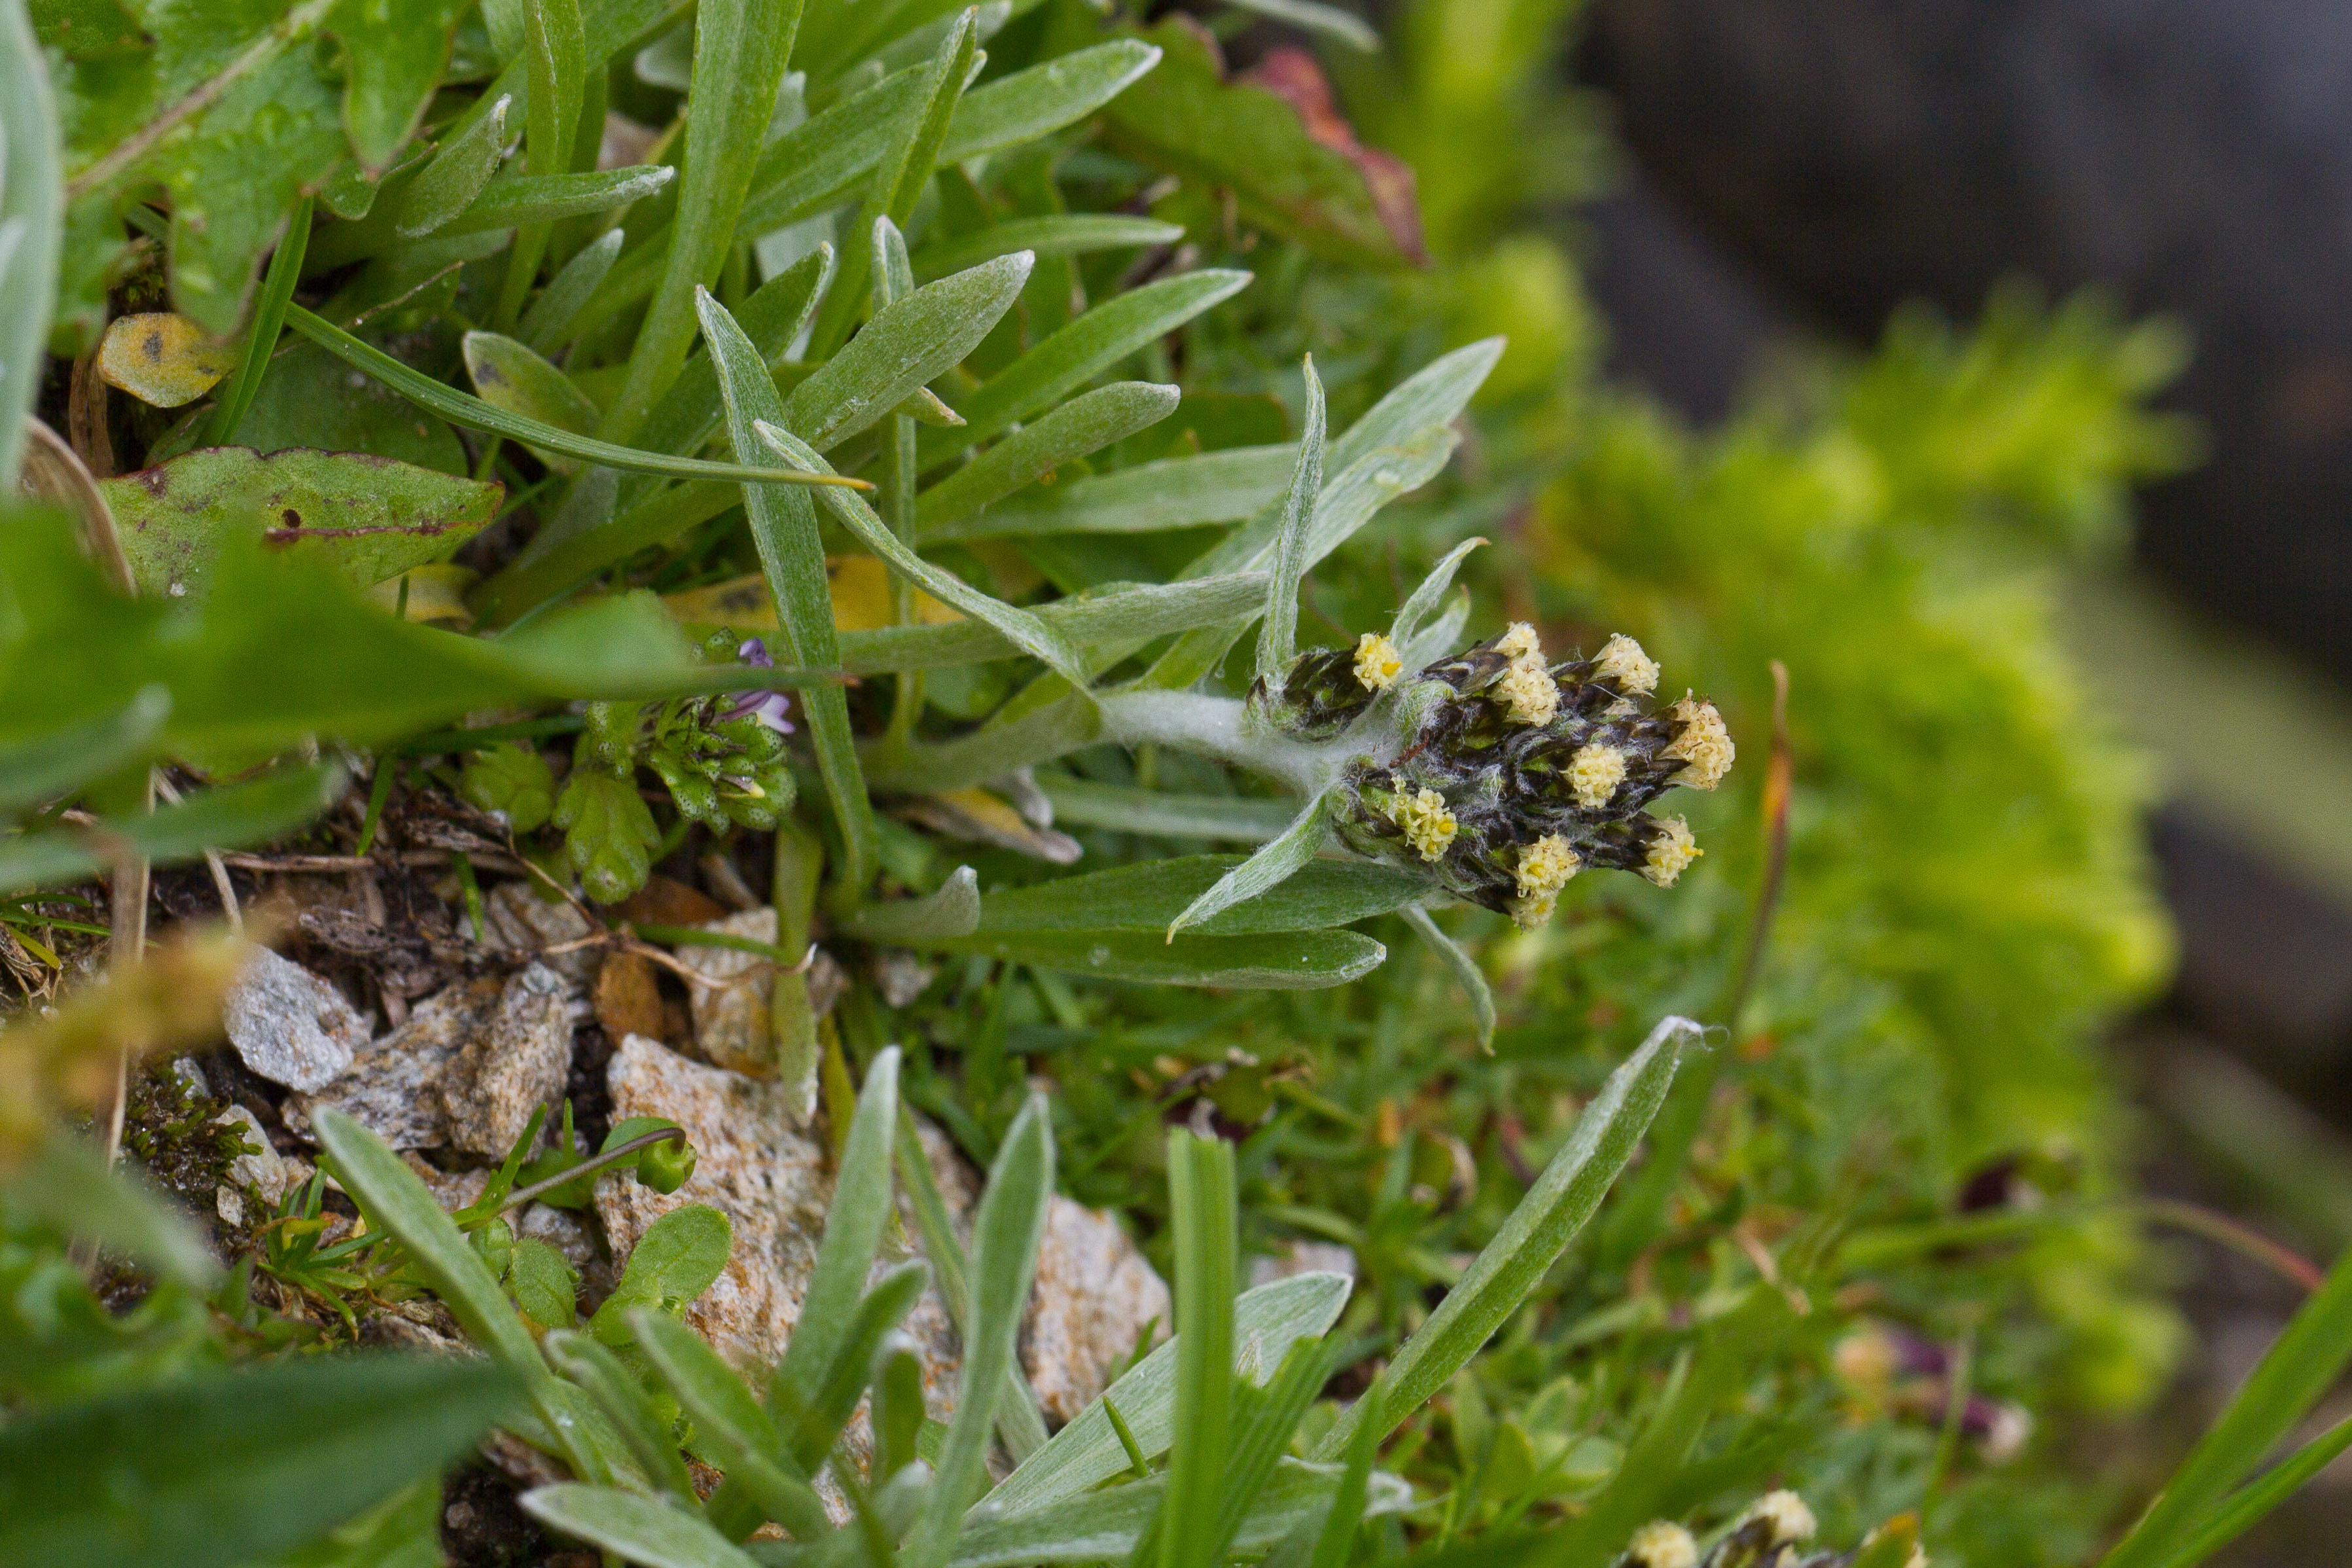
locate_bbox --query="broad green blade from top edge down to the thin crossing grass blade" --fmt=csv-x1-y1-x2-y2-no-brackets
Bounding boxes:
602,0,802,449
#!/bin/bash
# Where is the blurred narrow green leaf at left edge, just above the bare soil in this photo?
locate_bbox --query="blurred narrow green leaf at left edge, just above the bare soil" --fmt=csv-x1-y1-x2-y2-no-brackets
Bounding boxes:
0,762,346,896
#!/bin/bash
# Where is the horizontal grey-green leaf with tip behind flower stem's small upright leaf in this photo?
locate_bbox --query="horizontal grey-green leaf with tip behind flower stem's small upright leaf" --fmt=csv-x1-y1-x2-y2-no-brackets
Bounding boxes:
924,447,1298,543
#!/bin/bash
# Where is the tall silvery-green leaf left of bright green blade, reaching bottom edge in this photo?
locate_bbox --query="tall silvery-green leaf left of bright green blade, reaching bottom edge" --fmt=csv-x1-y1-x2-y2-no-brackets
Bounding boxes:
901,1096,1054,1568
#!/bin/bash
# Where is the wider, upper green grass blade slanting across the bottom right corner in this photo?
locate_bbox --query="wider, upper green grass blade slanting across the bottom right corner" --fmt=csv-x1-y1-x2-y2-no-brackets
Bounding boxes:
2103,1251,2352,1568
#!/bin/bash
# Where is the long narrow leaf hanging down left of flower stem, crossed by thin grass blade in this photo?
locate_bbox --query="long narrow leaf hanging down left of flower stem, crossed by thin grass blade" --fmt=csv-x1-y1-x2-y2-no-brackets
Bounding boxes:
698,294,880,893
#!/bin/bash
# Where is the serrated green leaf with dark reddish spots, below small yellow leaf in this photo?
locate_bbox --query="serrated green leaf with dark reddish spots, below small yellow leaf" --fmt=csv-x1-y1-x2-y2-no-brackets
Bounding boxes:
99,447,506,597
